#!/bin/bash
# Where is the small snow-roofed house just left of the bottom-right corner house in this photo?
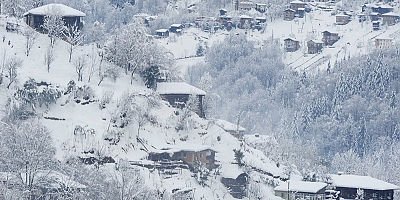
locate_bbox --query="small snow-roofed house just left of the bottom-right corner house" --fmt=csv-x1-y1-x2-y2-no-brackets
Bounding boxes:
274,180,327,200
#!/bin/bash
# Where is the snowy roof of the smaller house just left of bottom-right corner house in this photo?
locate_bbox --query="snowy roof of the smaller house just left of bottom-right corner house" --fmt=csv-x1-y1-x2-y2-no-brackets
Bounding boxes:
274,180,327,194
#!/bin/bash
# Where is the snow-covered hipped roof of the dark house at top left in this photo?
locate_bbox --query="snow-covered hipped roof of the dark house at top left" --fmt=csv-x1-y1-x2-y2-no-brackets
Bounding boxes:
24,3,86,17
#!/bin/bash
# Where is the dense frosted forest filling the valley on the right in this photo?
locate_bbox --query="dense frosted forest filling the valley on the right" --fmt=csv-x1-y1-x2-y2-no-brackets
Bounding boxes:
188,35,400,186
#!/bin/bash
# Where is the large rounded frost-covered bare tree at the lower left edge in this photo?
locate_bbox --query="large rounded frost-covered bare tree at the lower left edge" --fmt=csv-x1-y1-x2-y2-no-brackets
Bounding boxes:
0,120,56,194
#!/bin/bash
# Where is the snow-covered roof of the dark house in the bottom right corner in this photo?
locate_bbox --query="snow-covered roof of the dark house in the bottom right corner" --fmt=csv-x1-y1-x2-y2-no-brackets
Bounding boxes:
330,174,400,190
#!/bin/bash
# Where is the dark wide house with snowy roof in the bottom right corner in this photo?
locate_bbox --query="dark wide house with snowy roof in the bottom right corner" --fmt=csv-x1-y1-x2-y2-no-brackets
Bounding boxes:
329,174,400,200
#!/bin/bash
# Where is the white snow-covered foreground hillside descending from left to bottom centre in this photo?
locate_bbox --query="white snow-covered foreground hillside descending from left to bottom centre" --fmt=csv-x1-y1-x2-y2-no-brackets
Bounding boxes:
0,16,283,199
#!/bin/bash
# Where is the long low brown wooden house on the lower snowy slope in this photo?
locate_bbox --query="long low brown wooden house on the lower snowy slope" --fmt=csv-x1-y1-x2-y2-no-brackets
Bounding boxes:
148,143,217,169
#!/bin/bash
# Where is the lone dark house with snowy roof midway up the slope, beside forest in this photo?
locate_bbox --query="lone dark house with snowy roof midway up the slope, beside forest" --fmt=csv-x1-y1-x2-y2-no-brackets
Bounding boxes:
157,82,206,118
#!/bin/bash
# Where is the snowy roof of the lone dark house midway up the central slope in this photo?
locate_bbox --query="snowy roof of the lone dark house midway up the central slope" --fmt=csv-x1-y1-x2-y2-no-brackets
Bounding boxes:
157,82,207,95
